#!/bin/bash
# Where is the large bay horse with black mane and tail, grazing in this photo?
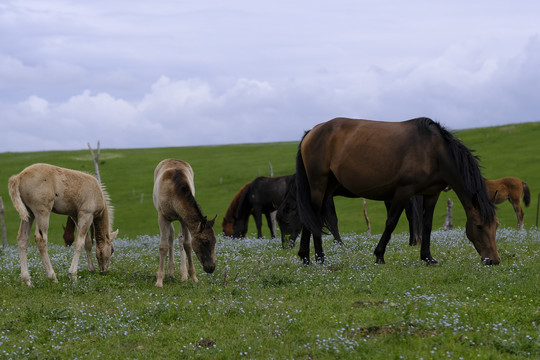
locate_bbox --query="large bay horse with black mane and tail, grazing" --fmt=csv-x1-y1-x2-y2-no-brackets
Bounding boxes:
296,118,500,265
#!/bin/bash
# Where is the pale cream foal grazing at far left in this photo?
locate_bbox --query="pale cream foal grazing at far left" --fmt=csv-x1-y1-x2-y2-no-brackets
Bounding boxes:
9,164,118,286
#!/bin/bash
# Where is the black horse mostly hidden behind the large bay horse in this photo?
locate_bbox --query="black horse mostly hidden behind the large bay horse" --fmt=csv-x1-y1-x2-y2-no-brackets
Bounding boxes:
276,174,422,249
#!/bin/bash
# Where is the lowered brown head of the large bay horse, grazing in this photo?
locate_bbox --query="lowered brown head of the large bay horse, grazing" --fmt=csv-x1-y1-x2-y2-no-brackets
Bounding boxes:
465,204,501,265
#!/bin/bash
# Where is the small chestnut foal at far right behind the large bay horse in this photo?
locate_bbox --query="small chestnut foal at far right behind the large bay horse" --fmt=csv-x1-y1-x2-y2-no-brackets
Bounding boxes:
485,177,531,230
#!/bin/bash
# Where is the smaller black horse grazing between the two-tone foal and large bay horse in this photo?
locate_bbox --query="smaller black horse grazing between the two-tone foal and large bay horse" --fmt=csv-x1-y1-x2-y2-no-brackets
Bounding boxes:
233,175,292,239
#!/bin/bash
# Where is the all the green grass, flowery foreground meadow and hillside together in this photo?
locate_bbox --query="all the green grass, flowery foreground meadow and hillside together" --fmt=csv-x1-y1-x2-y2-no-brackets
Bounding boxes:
0,123,540,359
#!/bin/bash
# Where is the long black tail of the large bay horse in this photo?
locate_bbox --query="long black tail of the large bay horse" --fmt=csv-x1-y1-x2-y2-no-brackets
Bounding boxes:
296,132,322,236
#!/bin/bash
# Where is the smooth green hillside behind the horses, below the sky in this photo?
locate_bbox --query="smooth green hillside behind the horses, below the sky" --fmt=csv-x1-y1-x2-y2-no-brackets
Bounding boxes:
0,123,540,244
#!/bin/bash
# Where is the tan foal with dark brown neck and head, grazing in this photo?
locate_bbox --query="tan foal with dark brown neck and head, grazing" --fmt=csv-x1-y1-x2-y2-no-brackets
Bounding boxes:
153,159,216,288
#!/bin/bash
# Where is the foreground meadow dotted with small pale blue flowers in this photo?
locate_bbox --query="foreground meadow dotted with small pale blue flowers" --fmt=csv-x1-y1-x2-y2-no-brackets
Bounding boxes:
0,228,540,360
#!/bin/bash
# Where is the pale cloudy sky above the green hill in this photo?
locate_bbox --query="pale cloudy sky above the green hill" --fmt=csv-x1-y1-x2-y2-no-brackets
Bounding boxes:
0,0,540,152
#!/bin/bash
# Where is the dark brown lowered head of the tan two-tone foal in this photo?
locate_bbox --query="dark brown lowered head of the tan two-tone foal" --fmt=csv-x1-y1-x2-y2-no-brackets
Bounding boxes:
192,215,217,274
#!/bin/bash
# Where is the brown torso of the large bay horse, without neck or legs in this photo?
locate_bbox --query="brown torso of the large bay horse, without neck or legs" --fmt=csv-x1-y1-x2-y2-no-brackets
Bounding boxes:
300,118,444,200
